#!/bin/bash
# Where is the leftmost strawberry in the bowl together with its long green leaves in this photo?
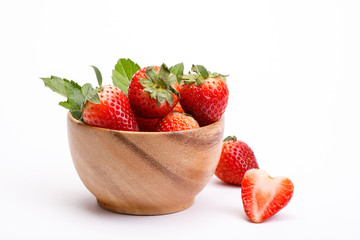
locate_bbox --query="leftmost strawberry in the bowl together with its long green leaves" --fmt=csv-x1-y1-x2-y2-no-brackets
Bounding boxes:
41,66,139,131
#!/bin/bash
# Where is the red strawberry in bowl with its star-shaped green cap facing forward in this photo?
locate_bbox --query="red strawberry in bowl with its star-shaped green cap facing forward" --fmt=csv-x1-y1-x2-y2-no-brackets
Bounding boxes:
128,64,179,118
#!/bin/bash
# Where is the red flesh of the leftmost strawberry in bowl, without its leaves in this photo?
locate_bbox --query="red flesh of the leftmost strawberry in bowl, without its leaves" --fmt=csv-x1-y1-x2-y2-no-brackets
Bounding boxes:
82,85,139,131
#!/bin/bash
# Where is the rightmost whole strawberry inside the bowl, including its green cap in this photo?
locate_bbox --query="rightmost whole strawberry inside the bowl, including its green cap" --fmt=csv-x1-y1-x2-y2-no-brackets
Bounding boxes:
180,65,229,126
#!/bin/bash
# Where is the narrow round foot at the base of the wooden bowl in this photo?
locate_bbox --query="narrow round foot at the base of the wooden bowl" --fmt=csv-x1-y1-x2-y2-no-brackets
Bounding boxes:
96,199,194,216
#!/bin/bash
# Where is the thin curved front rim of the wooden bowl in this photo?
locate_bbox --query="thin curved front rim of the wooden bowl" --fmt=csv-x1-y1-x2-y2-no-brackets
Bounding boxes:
67,111,224,135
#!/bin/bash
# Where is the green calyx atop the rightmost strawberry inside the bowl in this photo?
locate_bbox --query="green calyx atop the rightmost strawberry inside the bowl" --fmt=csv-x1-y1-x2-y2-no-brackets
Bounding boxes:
178,64,229,86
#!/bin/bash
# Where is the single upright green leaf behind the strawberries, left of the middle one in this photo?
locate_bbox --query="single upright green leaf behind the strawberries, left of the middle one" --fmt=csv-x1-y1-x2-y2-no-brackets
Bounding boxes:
111,58,140,95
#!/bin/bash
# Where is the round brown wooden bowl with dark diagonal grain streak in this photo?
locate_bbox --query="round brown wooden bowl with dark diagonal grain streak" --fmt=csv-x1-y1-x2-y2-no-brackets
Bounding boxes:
68,113,224,215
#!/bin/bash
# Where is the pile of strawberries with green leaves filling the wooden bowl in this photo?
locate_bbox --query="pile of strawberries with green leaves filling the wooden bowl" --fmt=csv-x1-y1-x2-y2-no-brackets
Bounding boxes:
42,59,229,131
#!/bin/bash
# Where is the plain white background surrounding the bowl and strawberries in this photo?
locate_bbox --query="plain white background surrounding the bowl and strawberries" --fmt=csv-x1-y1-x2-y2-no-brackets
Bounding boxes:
0,0,360,239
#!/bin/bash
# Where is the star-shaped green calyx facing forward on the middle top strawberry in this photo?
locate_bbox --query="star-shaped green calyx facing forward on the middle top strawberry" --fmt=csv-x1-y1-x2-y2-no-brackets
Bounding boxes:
139,63,180,106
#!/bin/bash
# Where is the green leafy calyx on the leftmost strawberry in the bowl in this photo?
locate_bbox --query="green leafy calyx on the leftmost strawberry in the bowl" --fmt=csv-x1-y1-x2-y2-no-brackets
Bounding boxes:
40,66,102,120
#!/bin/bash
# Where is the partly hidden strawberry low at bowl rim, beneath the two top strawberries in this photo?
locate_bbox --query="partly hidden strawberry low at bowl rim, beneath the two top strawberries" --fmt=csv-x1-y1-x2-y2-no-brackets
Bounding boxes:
156,112,199,132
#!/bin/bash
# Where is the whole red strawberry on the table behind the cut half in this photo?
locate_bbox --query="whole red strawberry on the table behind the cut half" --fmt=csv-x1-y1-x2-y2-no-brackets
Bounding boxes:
215,136,259,185
